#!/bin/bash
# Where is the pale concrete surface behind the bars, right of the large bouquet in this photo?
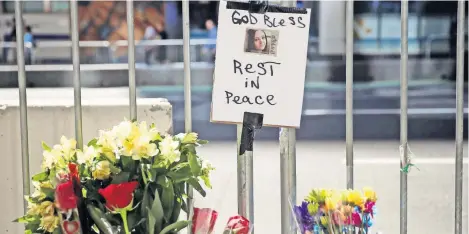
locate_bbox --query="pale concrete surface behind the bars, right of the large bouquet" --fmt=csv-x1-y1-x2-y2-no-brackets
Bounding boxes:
195,141,468,234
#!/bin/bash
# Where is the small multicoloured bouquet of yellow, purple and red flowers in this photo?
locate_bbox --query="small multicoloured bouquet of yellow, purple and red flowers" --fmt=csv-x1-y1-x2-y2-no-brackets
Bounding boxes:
294,188,377,234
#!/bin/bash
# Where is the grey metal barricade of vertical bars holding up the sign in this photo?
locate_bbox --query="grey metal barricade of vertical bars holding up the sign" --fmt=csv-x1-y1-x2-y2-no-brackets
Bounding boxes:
9,0,465,234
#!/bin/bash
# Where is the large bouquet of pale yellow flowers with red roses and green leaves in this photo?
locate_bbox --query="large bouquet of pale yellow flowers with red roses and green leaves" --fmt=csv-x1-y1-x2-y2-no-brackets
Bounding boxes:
15,121,214,234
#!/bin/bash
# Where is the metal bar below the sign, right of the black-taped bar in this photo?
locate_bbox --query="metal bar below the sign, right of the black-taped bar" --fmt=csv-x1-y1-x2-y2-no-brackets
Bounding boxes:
279,0,296,234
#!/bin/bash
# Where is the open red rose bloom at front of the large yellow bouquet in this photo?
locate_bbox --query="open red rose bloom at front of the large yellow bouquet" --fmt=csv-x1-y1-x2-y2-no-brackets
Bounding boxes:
98,181,138,211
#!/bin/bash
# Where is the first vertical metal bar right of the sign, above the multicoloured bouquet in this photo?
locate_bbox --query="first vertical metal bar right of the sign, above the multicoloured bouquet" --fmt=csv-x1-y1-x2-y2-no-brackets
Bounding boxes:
345,0,354,189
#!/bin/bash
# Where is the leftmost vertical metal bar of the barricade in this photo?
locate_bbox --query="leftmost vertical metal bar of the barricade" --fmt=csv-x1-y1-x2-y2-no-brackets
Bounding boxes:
15,0,31,211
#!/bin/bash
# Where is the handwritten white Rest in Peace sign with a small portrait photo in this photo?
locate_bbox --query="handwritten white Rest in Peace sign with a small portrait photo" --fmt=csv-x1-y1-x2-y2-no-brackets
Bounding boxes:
211,1,311,128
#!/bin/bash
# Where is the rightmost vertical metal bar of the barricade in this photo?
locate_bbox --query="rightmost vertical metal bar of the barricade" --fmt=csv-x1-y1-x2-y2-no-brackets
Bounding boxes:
454,0,466,234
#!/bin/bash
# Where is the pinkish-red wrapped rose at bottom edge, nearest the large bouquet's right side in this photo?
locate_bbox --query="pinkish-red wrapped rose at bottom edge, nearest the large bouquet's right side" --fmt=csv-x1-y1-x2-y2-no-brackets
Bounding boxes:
192,208,218,234
